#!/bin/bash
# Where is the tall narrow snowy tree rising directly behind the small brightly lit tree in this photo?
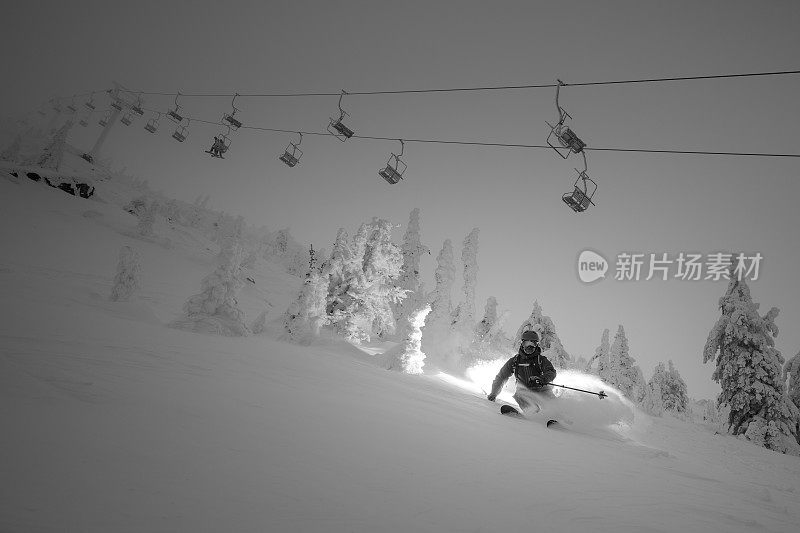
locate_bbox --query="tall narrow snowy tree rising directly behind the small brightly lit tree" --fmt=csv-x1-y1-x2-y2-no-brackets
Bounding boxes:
392,208,431,338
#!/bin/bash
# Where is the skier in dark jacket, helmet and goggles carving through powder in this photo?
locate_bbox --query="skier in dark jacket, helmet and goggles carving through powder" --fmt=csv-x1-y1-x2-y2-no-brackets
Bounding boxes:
487,330,556,410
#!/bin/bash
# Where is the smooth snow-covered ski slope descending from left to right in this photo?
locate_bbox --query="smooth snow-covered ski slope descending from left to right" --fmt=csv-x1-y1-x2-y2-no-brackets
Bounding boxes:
0,161,800,533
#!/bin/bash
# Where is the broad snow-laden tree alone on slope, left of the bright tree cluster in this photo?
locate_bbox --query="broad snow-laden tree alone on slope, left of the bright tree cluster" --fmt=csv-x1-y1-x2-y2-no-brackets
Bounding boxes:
171,242,250,336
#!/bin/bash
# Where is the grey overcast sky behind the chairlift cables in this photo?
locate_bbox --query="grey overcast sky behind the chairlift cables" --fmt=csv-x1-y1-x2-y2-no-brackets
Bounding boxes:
0,1,800,397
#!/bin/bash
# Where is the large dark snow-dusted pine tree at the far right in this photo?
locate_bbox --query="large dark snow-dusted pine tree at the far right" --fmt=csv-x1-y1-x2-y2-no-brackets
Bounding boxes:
703,276,800,455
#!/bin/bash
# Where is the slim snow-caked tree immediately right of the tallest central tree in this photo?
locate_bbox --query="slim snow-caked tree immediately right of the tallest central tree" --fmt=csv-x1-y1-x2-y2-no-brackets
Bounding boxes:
422,239,456,360
